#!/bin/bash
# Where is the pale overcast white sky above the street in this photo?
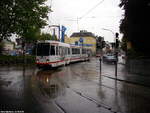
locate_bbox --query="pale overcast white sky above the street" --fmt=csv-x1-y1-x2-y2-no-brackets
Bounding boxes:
45,0,124,42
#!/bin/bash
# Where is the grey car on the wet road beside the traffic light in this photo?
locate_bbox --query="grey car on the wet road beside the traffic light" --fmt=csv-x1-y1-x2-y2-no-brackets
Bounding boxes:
103,54,116,63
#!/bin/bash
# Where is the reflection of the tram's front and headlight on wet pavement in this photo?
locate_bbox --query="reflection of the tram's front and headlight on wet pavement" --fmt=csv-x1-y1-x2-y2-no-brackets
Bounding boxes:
33,70,65,98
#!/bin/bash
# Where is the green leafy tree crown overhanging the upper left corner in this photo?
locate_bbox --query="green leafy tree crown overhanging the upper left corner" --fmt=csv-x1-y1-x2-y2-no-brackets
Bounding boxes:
0,0,50,40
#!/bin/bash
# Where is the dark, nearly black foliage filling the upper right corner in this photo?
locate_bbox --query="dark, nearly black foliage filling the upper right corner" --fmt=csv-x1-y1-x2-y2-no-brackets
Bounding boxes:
120,0,150,56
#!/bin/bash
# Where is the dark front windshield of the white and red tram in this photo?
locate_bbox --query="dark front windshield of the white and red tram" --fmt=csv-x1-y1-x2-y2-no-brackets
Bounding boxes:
37,43,50,56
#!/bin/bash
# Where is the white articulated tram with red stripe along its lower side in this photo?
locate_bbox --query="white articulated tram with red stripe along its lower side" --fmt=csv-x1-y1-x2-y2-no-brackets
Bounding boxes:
36,40,91,68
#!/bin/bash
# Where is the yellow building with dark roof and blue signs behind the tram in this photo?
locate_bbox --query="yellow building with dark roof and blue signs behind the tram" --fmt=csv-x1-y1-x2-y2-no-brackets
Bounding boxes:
65,30,96,55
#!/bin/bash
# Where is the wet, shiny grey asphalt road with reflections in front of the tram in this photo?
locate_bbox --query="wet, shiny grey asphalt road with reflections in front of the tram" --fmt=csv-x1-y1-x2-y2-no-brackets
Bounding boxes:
0,58,150,113
